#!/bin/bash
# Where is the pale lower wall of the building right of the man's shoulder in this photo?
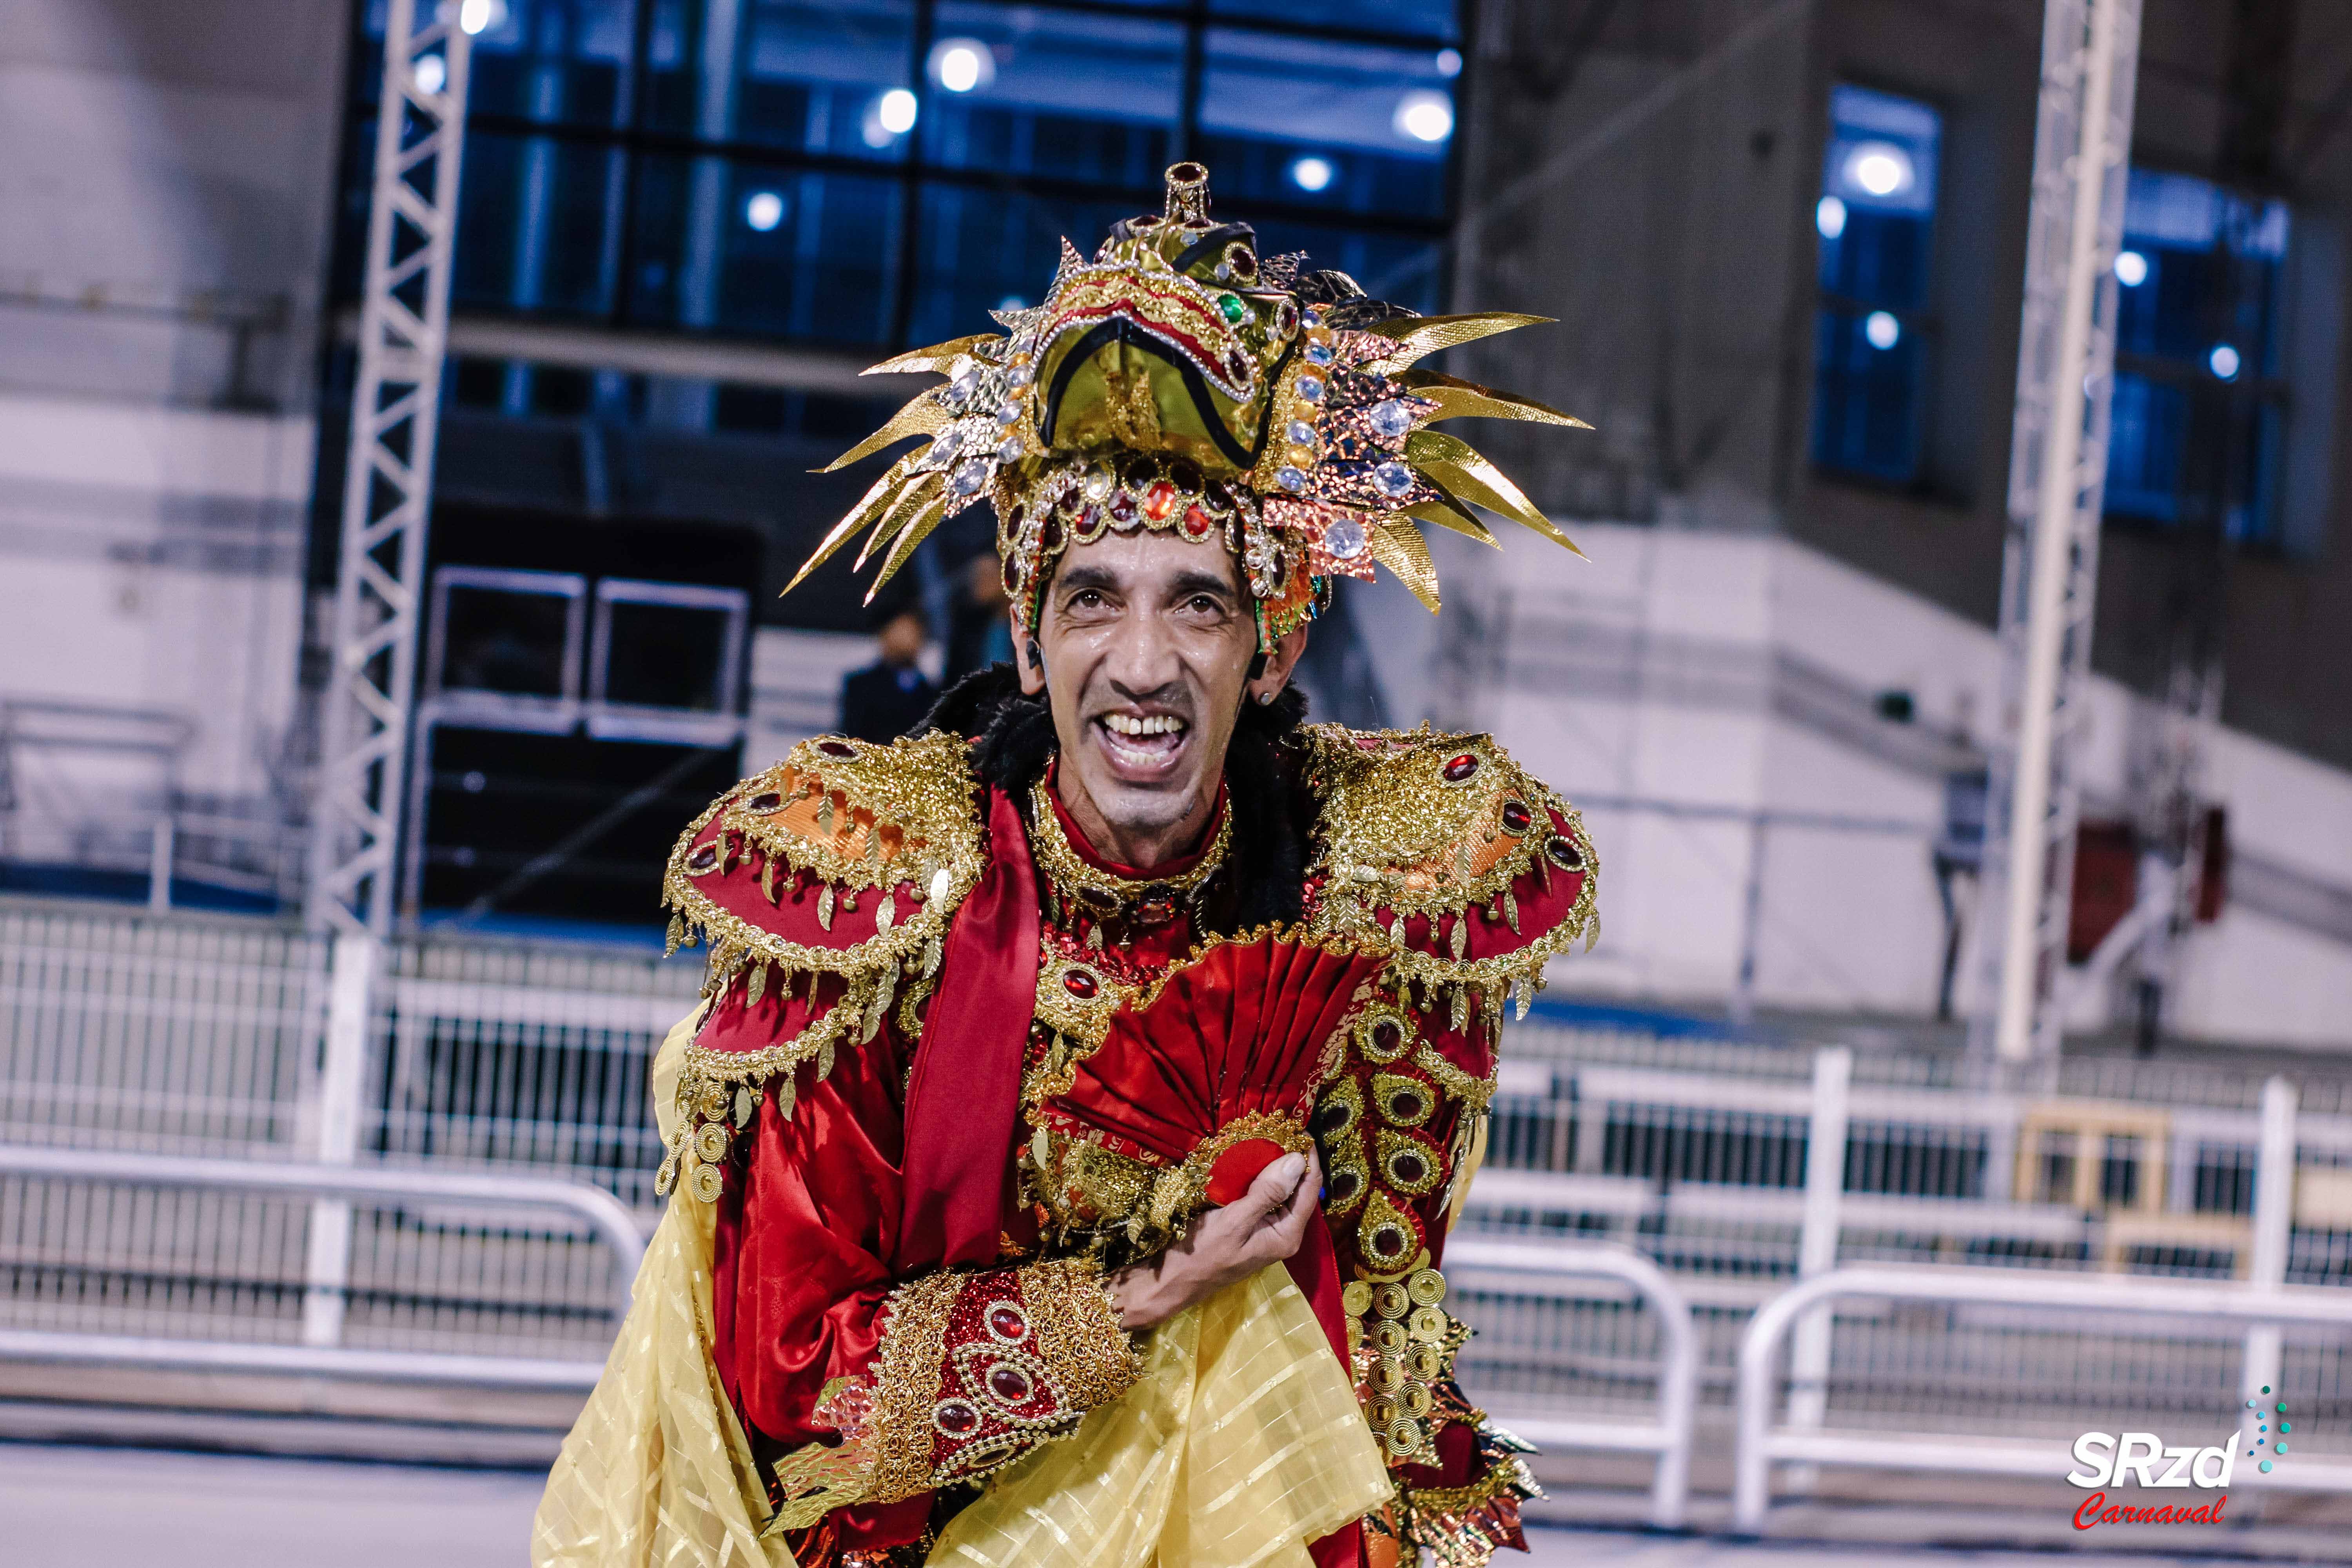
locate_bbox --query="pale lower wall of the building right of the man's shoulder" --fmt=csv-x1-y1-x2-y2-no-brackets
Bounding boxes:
1367,524,2352,1049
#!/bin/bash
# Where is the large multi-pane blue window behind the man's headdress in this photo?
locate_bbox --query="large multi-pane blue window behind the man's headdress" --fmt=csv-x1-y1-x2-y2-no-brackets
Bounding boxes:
336,0,1463,376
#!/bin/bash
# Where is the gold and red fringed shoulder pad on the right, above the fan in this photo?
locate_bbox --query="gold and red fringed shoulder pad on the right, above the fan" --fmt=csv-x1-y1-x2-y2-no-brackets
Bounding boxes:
1305,724,1599,1016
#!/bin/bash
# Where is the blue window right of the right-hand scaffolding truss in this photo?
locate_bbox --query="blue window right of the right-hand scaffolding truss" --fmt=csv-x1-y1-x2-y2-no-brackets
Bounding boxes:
2107,169,2288,543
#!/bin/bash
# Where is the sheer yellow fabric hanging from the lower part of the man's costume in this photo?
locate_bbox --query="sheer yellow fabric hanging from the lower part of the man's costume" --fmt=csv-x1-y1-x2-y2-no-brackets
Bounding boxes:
532,1018,1390,1568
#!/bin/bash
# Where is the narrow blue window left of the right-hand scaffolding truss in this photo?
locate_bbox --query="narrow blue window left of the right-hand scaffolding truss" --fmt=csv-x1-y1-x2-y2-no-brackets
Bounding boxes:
1813,87,1943,484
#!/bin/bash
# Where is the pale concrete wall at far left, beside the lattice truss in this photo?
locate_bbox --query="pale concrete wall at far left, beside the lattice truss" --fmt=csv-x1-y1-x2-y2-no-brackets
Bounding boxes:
0,0,348,884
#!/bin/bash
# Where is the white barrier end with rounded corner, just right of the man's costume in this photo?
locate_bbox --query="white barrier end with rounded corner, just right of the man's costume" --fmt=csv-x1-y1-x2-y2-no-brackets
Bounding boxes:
1446,1236,1698,1530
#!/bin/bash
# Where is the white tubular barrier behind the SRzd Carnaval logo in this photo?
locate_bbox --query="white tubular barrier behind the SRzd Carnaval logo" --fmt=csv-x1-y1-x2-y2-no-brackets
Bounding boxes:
1731,1267,2352,1535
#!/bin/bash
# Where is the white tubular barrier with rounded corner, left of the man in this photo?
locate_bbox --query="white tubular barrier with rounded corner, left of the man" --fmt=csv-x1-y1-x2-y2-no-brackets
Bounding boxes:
0,1145,644,1389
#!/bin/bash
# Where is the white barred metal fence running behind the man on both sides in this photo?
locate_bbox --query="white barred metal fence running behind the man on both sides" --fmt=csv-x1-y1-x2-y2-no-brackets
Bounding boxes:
0,898,2352,1504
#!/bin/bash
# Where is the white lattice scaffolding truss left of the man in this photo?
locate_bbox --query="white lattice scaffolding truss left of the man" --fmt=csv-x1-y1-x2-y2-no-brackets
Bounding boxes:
306,0,489,936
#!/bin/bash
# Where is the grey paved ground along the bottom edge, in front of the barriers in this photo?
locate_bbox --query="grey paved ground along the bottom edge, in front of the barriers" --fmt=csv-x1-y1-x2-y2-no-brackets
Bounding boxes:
0,1443,2314,1568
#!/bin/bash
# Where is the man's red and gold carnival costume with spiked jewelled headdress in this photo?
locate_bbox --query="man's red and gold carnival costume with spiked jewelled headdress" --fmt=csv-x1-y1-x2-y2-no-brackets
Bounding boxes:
534,165,1597,1568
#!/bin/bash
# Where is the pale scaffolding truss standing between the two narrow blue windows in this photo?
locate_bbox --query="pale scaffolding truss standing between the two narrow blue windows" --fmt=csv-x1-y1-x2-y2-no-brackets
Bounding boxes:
1971,0,2140,1074
